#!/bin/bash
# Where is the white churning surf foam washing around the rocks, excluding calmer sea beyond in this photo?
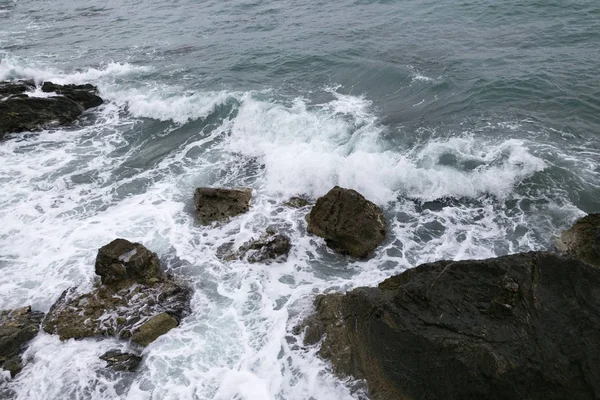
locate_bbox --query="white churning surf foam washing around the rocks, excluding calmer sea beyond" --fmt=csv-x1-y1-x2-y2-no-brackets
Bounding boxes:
0,58,598,400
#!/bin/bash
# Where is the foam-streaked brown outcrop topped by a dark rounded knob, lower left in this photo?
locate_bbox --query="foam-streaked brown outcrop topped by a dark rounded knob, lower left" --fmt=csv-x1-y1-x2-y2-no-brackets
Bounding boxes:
43,239,192,346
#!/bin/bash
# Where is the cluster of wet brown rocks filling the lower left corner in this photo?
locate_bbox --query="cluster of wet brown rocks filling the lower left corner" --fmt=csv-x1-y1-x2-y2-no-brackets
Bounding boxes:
0,239,192,376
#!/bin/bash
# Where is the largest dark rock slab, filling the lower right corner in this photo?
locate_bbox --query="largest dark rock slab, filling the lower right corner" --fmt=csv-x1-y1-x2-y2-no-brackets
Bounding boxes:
305,252,600,400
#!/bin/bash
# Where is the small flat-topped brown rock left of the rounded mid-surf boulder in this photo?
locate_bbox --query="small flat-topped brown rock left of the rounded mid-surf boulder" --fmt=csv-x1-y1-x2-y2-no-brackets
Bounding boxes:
194,188,252,225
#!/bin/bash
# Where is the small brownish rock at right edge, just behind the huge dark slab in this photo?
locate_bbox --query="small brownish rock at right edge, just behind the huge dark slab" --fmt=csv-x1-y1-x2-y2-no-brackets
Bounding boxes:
557,213,600,267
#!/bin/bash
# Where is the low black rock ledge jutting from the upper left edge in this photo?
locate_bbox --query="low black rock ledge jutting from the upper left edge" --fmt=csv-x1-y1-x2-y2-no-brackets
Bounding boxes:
0,81,102,137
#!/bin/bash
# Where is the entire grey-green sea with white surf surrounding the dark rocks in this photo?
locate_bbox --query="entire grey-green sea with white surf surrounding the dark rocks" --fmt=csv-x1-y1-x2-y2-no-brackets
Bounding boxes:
0,0,600,400
